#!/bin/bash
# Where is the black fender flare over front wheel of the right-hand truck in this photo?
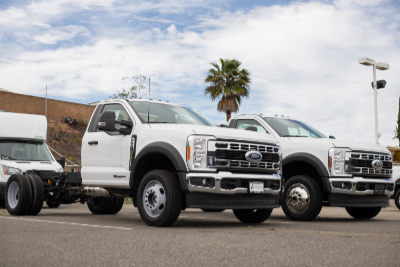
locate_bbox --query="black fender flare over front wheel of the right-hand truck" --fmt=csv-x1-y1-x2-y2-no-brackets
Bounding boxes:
282,152,330,192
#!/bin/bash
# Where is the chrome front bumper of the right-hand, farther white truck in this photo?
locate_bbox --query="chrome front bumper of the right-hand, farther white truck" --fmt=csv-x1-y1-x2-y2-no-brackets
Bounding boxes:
329,177,394,197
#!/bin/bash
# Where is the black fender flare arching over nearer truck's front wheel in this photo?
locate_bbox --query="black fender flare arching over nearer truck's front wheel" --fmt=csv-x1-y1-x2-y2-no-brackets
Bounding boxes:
129,142,187,189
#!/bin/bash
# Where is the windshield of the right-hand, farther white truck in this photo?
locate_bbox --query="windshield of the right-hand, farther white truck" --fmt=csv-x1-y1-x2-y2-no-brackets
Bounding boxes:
263,117,326,138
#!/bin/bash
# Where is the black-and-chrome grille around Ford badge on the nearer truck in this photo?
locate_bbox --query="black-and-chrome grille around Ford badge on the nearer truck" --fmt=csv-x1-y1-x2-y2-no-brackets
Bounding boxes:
207,140,280,170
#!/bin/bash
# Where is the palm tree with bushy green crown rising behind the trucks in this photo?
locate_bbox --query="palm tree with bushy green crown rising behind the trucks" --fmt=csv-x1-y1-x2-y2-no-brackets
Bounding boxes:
204,58,251,121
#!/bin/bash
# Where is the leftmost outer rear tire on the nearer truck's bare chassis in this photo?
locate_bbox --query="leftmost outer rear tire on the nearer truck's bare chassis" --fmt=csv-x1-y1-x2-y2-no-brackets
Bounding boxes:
5,174,32,215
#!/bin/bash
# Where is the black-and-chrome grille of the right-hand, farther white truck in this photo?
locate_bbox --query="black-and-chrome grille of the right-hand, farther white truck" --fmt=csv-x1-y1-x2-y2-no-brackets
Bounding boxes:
346,152,392,177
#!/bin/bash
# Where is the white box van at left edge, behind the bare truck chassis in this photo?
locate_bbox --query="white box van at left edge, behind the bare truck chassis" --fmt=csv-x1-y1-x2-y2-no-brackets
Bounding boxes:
0,112,65,207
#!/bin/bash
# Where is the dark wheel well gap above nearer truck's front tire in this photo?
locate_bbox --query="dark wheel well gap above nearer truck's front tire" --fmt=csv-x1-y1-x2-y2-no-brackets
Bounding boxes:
133,152,178,189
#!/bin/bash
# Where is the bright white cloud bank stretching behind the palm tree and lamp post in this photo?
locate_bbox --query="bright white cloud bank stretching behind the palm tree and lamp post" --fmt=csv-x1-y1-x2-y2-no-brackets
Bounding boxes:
0,1,400,145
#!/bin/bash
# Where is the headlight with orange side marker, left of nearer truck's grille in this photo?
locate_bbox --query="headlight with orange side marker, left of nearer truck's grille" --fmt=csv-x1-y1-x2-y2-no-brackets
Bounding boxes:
186,135,215,171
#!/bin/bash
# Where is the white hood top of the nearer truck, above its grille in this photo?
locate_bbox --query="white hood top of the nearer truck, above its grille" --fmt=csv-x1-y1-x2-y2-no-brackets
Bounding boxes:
150,124,277,144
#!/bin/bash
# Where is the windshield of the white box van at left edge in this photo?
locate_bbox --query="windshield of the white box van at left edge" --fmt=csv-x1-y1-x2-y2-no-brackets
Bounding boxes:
0,140,53,161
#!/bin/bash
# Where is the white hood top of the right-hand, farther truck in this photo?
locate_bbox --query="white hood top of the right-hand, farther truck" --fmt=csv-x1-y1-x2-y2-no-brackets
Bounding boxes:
288,137,390,154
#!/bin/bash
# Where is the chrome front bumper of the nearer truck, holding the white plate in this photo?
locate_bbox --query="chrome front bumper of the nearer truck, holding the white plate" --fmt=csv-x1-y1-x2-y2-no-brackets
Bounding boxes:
186,172,281,195
